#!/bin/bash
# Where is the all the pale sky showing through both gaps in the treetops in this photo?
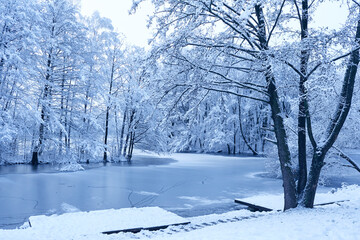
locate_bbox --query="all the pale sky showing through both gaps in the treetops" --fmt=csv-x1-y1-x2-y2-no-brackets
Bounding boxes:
81,0,347,47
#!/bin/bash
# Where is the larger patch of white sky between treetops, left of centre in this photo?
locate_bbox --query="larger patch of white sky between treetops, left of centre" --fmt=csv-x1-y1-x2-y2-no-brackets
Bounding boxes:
81,0,154,46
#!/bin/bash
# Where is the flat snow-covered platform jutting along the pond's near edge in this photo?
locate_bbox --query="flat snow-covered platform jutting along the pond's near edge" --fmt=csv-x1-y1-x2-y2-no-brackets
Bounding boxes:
29,207,189,234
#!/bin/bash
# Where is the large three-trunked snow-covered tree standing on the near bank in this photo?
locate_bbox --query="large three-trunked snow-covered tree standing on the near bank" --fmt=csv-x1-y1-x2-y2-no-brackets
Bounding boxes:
139,0,360,209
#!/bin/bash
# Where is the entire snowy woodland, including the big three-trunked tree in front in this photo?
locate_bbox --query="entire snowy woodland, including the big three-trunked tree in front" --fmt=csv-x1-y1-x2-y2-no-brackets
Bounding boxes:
0,0,360,209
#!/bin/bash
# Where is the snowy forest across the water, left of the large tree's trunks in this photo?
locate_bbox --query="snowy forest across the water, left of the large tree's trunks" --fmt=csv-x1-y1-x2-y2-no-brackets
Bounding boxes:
0,0,276,164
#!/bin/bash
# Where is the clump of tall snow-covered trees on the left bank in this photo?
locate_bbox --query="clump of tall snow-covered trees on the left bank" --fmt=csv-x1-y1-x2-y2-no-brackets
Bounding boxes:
0,0,153,164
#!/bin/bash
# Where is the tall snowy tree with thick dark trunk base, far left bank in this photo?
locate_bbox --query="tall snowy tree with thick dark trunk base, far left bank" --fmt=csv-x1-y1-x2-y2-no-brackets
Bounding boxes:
32,0,84,164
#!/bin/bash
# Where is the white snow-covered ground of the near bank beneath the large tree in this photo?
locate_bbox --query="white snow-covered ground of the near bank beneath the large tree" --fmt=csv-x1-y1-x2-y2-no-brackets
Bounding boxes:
0,185,360,240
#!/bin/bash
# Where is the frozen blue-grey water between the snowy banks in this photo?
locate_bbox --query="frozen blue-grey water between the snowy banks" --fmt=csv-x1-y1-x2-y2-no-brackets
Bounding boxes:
0,154,355,228
